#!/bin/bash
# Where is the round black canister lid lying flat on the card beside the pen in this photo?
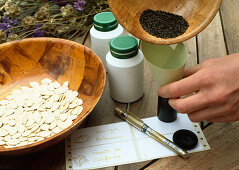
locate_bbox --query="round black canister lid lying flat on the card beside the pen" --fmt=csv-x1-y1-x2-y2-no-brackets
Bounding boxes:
173,129,198,150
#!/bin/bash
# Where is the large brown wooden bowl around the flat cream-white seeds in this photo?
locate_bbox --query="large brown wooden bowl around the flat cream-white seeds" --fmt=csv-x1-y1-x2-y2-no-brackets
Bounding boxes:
0,38,106,155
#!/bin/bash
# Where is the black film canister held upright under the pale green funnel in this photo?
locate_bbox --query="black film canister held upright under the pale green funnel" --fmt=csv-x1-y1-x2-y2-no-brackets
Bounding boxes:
158,96,177,123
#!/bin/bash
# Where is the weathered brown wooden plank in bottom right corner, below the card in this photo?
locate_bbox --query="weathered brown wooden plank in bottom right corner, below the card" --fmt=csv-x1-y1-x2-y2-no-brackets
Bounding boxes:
147,122,239,170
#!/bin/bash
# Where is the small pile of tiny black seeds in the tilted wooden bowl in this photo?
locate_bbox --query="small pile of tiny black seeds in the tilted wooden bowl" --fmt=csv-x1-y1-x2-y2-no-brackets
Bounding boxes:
139,9,189,39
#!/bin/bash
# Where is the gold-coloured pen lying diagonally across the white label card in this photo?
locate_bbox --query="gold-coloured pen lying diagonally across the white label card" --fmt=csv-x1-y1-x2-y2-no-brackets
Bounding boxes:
114,107,188,157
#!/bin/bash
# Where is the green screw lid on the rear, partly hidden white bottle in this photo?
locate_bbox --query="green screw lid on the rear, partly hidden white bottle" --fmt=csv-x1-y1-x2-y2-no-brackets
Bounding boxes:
93,12,118,32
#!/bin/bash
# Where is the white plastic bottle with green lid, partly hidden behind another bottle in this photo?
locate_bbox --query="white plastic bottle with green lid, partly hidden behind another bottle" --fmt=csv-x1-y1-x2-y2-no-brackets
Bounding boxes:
90,12,124,67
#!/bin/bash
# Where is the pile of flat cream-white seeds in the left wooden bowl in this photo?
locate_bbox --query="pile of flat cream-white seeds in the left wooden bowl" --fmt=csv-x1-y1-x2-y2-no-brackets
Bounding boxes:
0,79,83,148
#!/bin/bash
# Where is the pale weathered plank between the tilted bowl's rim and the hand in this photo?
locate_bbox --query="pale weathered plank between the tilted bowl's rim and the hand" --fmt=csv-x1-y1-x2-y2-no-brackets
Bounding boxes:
197,13,227,63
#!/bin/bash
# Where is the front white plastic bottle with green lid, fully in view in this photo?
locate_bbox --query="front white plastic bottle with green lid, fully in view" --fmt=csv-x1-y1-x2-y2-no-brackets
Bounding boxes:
106,35,144,103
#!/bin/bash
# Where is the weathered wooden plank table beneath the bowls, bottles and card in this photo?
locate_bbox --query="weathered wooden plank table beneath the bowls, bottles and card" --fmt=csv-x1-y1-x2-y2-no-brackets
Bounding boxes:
0,0,239,170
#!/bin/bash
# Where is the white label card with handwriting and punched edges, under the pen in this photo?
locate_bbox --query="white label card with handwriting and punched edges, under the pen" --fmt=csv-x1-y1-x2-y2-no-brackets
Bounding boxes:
66,114,210,170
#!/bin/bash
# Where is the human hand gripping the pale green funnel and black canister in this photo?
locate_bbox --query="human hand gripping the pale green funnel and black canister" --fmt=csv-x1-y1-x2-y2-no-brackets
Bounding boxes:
158,53,239,122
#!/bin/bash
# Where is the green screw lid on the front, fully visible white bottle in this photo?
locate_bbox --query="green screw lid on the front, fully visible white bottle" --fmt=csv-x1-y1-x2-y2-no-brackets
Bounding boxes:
109,35,139,59
